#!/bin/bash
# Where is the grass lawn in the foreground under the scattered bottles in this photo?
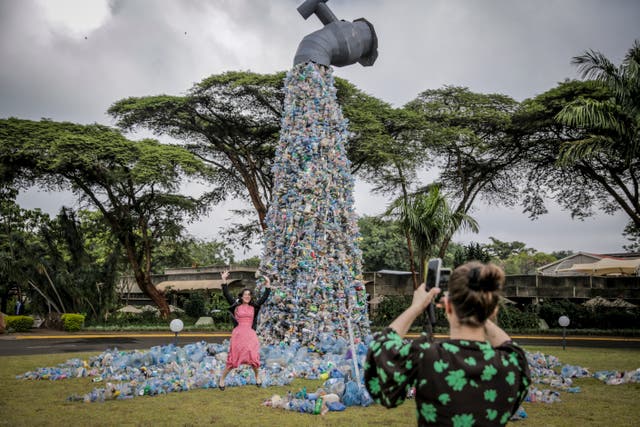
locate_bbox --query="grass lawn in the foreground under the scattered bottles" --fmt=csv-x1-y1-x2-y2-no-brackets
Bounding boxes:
0,347,640,427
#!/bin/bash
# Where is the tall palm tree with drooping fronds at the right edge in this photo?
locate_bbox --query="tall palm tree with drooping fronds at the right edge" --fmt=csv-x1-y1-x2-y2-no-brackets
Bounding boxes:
556,40,640,228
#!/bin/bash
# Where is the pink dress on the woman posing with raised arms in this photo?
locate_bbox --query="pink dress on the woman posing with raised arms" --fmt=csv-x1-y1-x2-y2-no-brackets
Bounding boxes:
227,304,260,368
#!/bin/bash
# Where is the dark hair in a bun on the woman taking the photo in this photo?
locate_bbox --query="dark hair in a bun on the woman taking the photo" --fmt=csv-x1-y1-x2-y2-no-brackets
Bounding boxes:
448,261,504,326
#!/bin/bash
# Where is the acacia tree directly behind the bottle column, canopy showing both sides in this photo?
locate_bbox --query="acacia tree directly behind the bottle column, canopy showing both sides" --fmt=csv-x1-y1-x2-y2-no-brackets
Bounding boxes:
109,71,412,244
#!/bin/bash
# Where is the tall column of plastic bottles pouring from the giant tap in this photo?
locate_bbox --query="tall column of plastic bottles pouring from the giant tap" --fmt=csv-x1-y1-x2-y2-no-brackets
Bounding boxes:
251,63,370,346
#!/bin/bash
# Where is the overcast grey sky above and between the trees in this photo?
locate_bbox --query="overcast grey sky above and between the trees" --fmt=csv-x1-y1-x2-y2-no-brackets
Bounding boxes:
0,0,640,258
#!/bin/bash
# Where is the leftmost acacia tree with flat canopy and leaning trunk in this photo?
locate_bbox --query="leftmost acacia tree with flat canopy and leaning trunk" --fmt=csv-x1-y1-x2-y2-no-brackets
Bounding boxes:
0,118,209,317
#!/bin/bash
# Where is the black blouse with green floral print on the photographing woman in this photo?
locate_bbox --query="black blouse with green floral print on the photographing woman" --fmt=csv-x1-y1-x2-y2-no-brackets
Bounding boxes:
365,328,531,427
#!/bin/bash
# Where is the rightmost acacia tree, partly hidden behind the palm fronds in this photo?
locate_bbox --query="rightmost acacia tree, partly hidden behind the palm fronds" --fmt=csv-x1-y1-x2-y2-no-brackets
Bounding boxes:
514,76,640,231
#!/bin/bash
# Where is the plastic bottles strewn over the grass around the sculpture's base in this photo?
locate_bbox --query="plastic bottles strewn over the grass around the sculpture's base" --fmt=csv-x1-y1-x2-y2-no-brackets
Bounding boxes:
17,334,640,412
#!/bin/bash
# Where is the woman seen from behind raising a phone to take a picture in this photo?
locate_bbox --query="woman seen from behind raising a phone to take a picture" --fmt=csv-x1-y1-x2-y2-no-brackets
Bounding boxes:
365,262,531,426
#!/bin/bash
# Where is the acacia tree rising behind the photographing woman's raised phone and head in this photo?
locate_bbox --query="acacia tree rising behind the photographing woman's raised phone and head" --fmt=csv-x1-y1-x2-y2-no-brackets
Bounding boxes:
406,86,522,258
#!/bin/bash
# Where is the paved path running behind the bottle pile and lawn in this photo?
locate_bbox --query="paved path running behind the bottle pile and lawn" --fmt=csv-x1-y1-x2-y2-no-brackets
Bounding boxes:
0,331,640,356
